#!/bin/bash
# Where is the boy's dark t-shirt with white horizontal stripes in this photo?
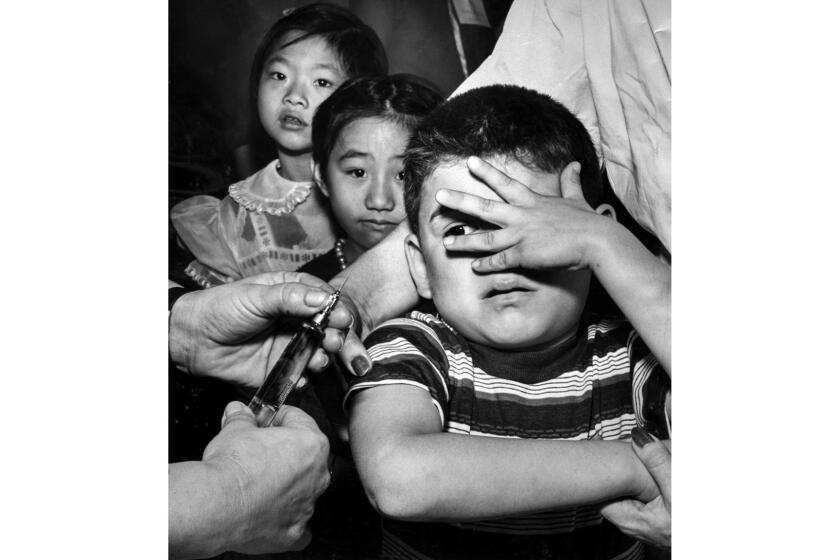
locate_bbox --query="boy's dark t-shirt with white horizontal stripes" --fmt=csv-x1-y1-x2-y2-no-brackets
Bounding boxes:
347,312,670,559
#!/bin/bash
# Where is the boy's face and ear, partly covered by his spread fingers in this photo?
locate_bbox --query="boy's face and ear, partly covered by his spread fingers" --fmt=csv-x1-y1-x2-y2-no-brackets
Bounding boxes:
406,157,590,350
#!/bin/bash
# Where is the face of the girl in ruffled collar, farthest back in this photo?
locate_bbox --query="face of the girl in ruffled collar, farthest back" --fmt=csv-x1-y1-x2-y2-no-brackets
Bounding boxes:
257,35,347,154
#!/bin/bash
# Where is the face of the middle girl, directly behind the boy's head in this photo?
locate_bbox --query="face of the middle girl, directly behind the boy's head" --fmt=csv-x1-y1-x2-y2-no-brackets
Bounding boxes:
322,117,410,255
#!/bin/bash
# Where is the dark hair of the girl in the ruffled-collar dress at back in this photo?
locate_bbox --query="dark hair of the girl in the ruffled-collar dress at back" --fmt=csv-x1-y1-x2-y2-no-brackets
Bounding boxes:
244,4,388,105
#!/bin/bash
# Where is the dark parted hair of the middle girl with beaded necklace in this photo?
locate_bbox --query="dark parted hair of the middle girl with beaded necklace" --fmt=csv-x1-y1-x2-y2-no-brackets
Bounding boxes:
312,74,443,177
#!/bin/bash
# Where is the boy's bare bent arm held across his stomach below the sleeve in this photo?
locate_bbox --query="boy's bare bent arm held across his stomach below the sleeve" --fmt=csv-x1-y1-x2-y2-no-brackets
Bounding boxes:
350,385,657,521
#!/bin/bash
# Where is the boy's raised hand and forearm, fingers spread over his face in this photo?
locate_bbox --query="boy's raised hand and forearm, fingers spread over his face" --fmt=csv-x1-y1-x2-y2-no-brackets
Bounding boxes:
436,157,671,374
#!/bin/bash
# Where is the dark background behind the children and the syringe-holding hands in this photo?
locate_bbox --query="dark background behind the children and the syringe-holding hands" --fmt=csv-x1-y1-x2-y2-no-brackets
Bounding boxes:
169,0,512,462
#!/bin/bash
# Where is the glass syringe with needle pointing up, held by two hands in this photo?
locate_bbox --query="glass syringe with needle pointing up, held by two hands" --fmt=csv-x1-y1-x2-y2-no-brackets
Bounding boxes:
248,288,341,427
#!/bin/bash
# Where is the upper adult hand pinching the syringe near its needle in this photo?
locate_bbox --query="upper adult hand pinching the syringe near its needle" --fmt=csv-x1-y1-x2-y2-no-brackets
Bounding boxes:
169,272,367,388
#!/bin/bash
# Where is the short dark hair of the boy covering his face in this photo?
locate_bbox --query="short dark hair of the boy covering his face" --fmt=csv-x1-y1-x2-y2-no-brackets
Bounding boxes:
404,85,604,233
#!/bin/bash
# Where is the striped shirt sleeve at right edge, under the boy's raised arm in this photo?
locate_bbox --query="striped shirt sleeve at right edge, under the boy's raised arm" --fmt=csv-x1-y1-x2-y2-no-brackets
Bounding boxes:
627,329,671,439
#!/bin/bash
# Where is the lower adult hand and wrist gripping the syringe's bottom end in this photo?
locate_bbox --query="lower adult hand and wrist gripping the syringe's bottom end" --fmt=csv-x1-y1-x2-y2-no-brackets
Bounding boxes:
169,402,329,559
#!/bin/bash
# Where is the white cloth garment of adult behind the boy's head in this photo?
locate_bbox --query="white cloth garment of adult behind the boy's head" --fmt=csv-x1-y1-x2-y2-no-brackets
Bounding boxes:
453,0,671,252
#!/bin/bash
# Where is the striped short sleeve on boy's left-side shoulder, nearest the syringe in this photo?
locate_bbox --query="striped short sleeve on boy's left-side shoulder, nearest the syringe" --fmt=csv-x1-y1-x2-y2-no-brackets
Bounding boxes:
344,314,449,425
